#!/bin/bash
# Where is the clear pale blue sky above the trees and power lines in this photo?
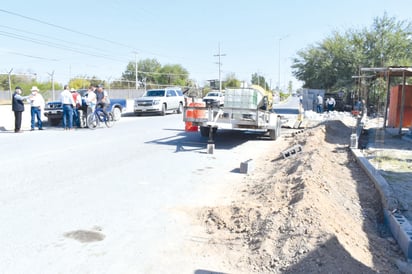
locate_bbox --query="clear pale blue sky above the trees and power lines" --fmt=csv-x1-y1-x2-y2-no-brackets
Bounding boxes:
0,0,412,88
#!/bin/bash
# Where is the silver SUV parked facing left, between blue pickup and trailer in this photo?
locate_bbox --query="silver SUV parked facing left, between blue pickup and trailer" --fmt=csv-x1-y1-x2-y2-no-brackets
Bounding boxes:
134,87,184,115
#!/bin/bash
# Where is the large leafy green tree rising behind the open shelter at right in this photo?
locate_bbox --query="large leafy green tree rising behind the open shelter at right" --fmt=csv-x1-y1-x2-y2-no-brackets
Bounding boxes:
292,14,412,91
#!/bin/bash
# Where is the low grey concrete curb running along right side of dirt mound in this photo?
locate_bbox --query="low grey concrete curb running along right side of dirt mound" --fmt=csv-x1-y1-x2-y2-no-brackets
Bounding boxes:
351,148,412,260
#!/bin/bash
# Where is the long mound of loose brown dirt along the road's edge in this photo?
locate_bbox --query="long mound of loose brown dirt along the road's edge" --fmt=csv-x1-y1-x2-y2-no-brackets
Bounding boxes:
198,121,403,273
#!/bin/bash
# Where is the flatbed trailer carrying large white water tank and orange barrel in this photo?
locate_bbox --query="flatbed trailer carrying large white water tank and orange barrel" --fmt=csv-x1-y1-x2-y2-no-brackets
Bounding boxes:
183,86,281,140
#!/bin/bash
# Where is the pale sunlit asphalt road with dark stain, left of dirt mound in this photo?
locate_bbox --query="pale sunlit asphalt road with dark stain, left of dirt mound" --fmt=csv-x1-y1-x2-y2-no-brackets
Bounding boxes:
0,107,284,273
